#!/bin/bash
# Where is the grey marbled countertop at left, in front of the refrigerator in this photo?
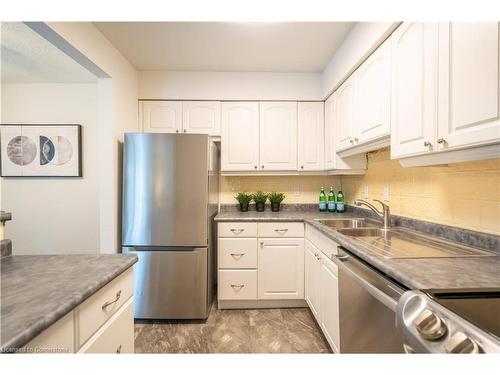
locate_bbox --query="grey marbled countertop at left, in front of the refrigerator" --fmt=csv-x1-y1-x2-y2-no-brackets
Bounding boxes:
0,254,137,353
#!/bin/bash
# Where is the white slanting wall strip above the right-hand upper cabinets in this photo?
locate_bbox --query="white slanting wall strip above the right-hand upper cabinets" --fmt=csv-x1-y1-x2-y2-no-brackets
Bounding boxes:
321,22,400,98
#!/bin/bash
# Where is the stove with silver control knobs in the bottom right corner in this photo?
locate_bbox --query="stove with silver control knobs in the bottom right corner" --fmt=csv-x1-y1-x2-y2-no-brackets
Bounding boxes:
396,289,500,353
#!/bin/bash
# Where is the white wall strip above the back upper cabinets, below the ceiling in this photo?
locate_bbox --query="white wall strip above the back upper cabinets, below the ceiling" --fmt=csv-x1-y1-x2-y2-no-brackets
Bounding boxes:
139,70,322,100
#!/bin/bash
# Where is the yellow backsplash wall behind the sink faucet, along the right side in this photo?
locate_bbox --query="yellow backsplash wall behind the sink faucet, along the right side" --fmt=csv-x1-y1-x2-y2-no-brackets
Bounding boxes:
342,149,500,235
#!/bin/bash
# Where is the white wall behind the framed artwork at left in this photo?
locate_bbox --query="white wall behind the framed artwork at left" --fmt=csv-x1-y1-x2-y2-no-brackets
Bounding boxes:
1,84,100,255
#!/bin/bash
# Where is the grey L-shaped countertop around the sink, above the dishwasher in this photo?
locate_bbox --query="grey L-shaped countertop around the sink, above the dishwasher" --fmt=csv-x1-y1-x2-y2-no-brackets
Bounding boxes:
215,209,500,289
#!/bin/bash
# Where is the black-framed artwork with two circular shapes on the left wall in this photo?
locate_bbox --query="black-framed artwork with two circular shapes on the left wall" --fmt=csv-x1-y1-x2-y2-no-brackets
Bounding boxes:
0,124,82,177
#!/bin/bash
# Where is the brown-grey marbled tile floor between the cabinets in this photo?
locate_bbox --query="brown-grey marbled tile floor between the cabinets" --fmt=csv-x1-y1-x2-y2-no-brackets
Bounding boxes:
135,307,331,353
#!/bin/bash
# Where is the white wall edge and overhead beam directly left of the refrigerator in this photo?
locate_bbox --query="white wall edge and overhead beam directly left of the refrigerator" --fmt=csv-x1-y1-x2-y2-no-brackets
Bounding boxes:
47,22,139,253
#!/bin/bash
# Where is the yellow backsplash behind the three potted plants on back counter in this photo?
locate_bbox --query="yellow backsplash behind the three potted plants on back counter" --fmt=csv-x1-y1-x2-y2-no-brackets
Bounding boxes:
220,176,340,204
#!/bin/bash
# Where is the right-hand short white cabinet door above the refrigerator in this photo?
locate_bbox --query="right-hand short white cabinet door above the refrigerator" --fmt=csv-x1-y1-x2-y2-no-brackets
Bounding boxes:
182,101,220,136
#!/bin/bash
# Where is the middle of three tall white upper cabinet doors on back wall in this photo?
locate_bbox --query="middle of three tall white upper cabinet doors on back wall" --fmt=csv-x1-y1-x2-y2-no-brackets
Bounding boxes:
260,102,297,171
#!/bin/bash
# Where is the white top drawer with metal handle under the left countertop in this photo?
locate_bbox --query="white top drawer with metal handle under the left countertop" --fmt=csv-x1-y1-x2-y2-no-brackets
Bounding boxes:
76,268,133,347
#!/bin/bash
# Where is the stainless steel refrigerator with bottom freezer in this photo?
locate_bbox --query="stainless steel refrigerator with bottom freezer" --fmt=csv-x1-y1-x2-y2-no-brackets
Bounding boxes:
122,133,219,319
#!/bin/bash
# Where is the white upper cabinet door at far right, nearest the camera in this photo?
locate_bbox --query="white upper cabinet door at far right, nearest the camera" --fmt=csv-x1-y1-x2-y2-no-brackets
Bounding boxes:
437,22,500,150
